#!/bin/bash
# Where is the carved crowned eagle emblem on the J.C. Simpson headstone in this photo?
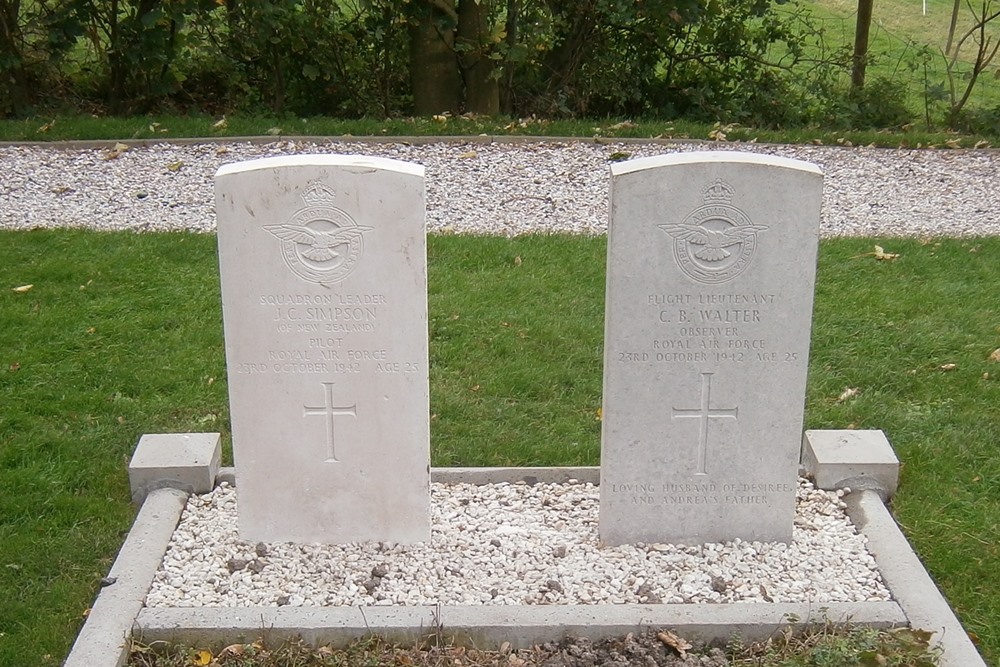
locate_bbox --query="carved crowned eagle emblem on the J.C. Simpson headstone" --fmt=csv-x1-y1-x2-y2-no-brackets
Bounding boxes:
264,182,373,284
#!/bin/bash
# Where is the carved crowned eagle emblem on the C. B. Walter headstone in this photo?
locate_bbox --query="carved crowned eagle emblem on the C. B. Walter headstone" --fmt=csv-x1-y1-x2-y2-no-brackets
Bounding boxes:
657,179,768,284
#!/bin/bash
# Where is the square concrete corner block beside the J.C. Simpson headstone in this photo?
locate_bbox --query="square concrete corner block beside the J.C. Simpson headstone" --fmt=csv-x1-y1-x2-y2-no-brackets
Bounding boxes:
128,433,222,503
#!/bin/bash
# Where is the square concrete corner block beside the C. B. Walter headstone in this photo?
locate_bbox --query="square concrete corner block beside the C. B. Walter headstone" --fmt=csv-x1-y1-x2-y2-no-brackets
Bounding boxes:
802,430,899,499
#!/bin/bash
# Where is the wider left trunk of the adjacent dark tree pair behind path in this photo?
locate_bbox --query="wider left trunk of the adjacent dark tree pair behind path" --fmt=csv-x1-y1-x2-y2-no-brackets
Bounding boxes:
410,2,462,116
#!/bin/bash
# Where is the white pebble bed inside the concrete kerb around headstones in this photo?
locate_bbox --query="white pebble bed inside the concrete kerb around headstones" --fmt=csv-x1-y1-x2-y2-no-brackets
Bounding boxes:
146,480,890,607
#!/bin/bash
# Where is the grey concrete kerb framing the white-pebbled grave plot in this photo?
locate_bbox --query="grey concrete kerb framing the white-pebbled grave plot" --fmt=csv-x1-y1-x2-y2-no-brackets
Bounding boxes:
64,432,986,667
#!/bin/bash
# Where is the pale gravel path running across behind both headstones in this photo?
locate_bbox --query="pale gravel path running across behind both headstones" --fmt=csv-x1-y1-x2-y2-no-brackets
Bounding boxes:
0,140,1000,236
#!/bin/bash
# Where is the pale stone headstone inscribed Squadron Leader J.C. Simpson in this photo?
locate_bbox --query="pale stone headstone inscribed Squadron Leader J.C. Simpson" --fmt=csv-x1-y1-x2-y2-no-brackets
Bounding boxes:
215,155,430,544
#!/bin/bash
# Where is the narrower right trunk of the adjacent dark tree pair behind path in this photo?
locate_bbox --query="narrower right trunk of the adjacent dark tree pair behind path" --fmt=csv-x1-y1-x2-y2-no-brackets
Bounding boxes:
455,0,500,116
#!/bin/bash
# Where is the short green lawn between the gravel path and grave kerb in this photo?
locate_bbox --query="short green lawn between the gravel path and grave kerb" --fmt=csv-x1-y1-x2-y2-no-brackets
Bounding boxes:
0,231,1000,665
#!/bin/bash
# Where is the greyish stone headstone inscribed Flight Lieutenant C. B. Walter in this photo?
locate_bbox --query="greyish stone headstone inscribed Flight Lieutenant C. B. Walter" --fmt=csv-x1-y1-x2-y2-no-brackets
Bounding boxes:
600,151,822,545
